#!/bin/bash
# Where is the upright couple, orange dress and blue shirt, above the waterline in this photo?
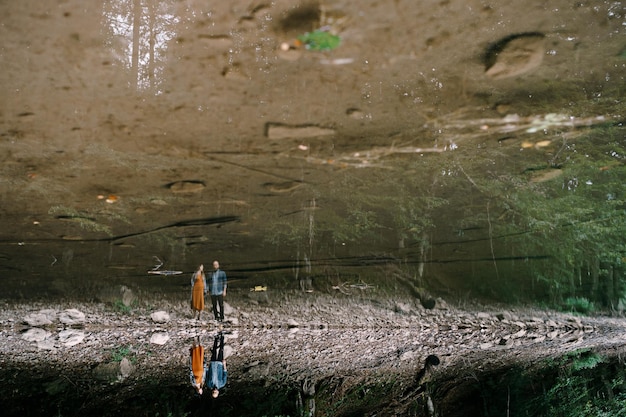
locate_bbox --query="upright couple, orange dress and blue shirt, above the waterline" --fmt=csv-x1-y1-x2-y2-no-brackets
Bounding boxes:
191,261,226,322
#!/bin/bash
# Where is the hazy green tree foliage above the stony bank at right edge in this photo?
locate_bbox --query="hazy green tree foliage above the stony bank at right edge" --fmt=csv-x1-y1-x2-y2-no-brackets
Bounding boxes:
448,122,626,304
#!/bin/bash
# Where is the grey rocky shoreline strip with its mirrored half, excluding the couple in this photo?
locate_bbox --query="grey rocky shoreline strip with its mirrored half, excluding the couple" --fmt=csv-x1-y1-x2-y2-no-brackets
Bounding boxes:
0,292,626,415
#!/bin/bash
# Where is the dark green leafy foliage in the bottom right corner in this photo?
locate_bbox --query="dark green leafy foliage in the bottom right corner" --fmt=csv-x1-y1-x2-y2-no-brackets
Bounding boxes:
478,348,626,417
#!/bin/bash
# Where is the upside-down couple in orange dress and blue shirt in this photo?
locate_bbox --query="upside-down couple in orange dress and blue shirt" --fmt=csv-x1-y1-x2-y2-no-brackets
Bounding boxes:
189,332,228,398
